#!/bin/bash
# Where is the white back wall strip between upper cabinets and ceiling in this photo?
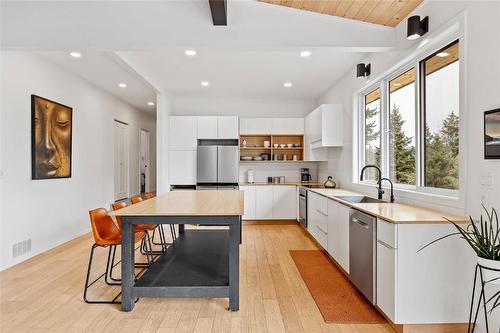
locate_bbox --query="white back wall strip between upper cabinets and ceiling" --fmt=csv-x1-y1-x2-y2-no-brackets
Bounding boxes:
172,96,316,118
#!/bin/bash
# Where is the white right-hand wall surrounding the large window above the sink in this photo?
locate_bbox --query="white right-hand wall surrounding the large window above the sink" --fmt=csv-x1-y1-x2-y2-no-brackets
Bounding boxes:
318,1,500,216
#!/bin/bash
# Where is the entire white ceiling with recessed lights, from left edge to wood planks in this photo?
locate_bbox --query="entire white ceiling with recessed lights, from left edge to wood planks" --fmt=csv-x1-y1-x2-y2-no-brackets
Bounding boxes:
0,0,396,110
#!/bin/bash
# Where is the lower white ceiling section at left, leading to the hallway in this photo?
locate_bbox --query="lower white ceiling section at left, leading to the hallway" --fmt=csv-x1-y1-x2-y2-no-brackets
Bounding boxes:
37,52,156,114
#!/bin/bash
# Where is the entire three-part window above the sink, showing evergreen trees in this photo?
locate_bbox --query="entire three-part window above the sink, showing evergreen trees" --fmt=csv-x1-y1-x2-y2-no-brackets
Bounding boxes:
358,40,459,194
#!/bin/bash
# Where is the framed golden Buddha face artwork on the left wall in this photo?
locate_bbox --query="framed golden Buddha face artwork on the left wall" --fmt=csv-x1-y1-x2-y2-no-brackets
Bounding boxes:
31,95,73,179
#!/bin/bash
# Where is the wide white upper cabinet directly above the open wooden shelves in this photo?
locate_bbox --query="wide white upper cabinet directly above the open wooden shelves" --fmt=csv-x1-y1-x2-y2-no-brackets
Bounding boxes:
240,118,304,135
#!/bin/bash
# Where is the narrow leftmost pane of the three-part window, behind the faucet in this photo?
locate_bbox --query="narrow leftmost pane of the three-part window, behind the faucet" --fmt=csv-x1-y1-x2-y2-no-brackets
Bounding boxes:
364,88,381,181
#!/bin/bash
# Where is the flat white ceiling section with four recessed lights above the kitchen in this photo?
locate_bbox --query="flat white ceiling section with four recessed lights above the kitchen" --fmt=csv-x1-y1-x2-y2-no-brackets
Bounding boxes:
118,47,364,99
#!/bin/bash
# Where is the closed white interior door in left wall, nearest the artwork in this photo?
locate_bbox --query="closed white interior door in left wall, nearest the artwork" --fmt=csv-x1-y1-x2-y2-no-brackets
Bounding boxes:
114,120,128,200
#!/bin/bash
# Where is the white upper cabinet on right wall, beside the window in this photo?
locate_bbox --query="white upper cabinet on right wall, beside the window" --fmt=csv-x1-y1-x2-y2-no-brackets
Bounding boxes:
305,104,344,149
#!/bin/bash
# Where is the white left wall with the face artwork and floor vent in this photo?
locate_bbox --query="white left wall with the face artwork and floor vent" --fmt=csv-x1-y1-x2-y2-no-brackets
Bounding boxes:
0,52,156,269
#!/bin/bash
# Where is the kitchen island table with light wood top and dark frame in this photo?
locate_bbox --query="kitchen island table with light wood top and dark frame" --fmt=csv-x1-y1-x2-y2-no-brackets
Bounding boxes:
111,190,243,311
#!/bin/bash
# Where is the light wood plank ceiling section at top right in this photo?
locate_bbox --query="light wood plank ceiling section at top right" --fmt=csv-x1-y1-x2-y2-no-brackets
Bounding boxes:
258,0,423,27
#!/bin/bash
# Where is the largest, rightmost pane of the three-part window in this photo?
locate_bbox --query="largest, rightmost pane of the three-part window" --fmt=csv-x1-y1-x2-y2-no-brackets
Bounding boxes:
420,42,459,190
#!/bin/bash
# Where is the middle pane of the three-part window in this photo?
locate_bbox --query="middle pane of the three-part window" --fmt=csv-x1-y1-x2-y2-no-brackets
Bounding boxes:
389,68,416,185
